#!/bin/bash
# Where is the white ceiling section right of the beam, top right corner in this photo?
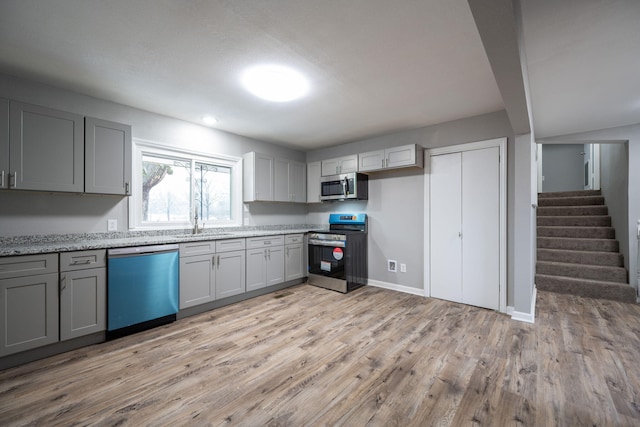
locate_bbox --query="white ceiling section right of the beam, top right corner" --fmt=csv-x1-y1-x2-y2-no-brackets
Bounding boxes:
522,0,640,139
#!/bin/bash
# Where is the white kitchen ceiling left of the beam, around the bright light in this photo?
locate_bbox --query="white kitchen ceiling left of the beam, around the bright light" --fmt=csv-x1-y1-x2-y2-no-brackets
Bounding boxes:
0,0,503,150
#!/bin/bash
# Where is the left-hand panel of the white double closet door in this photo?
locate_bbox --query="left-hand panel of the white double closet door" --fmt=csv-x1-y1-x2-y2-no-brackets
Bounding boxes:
429,153,462,302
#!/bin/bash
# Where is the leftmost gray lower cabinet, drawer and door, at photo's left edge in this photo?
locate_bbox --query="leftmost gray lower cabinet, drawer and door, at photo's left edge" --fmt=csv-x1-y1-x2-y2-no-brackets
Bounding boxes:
0,254,59,356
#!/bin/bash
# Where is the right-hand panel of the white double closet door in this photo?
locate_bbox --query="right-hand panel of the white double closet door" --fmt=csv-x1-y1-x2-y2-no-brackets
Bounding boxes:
462,147,500,310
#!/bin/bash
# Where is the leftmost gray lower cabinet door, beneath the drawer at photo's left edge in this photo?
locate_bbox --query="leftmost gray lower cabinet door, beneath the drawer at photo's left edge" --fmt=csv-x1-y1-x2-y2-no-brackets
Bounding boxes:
0,273,58,356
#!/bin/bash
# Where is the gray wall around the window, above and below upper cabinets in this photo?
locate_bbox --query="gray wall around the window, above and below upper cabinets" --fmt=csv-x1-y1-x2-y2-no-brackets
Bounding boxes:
0,74,306,236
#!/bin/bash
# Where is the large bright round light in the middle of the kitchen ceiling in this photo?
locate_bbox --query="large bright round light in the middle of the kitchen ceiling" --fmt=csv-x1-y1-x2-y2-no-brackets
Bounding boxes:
242,65,309,102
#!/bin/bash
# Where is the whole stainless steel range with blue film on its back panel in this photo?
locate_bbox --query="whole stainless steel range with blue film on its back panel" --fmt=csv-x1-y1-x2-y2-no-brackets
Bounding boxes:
309,214,368,293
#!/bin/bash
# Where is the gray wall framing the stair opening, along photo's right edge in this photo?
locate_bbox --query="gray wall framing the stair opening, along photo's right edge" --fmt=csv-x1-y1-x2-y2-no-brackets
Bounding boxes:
548,124,640,296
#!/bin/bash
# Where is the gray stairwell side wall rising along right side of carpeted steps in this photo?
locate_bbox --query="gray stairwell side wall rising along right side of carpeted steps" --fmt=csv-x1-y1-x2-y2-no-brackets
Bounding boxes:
600,143,633,270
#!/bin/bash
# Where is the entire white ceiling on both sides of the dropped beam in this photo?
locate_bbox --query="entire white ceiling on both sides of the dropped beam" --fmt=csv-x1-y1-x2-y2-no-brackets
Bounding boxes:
0,0,640,150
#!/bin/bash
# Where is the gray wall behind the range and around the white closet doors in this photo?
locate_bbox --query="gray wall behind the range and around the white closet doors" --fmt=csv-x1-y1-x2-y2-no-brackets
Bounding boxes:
307,111,514,305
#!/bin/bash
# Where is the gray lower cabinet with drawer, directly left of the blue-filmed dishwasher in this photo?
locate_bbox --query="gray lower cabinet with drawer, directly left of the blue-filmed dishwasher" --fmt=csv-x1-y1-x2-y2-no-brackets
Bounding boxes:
60,249,107,341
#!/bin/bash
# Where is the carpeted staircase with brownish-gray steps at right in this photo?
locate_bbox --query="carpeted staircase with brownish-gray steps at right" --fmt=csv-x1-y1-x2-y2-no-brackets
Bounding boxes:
536,190,636,303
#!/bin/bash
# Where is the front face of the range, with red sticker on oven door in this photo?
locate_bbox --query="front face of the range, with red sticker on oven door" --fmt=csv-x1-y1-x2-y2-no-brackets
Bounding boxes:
309,238,347,292
